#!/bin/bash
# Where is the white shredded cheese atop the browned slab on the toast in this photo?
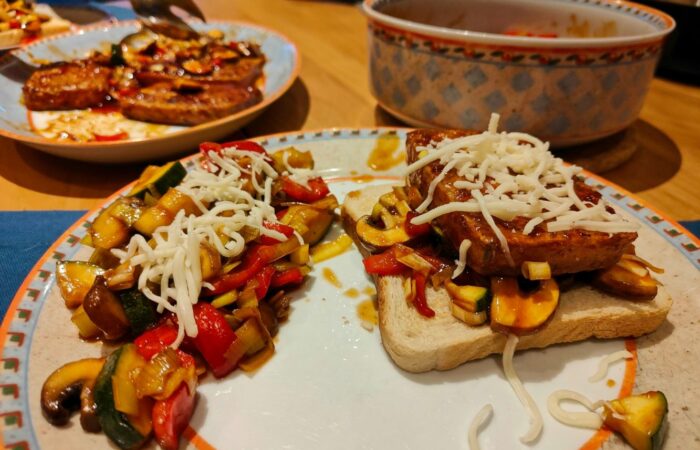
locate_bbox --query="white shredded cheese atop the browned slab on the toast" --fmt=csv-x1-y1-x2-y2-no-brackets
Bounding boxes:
406,114,637,265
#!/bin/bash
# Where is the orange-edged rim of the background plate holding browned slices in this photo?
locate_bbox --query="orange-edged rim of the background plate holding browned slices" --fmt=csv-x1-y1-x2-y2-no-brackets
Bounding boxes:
0,19,301,152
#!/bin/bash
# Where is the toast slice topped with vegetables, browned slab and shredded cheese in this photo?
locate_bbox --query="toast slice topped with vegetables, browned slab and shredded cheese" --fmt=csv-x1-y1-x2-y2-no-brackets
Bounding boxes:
342,114,672,445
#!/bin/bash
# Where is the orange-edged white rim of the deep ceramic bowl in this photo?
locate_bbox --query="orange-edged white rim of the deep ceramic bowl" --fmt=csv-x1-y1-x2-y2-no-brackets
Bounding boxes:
362,0,676,48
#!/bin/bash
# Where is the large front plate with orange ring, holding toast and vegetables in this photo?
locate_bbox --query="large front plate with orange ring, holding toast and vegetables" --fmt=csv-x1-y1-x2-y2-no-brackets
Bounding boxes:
0,128,700,449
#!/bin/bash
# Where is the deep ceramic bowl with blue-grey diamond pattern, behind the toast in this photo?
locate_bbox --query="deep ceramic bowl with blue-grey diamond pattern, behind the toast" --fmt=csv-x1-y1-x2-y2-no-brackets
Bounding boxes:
363,0,675,147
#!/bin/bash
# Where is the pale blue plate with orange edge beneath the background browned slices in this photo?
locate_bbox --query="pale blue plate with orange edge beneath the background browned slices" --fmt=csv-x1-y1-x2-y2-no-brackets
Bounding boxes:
0,21,300,163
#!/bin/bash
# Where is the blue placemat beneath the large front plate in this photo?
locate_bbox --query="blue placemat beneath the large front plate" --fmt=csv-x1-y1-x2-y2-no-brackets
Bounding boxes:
0,211,700,317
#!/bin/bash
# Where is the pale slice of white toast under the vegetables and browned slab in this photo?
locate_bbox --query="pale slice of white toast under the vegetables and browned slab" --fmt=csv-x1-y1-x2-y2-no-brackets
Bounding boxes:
342,185,672,372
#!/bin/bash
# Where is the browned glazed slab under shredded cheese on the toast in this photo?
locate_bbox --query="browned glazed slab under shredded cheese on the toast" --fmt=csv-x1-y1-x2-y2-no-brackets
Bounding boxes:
406,130,637,276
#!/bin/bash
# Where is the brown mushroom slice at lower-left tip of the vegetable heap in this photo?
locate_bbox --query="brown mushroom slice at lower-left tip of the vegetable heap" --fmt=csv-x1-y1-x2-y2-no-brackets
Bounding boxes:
41,358,105,431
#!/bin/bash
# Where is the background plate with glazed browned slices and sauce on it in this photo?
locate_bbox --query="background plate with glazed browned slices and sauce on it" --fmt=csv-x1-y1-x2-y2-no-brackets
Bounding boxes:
0,22,300,162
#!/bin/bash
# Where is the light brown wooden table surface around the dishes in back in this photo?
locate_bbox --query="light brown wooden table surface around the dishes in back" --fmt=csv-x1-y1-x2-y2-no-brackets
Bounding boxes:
0,0,700,220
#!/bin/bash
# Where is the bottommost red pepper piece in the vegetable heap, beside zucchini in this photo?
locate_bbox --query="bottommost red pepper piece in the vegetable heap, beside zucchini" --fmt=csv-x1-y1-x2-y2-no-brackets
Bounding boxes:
152,383,195,450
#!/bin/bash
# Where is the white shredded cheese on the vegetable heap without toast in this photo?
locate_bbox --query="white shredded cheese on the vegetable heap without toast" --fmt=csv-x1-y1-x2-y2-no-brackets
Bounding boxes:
112,148,316,348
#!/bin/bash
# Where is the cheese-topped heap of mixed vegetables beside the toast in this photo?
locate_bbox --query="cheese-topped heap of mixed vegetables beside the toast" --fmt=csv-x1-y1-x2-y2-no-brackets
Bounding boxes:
41,141,338,449
